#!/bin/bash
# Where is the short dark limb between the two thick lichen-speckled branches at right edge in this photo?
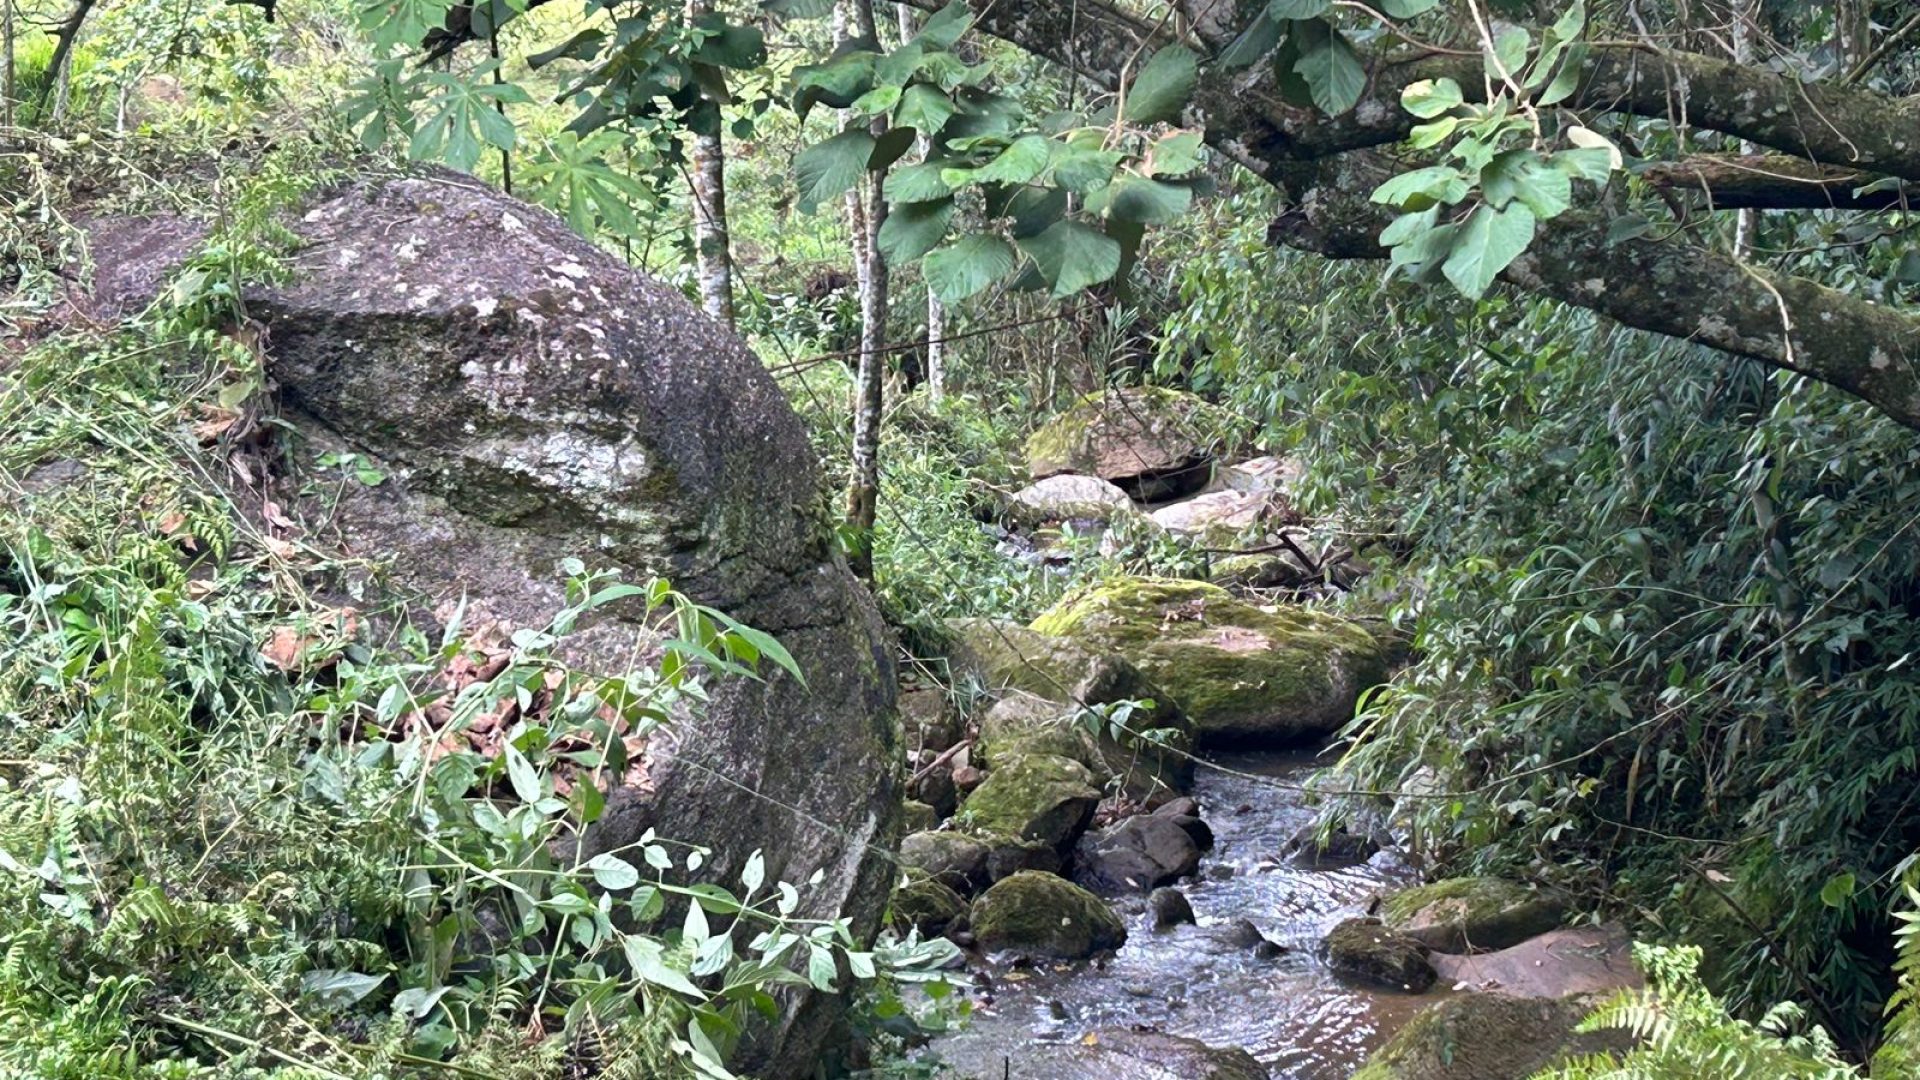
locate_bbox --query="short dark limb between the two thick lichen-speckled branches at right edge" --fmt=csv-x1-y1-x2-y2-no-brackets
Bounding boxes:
1640,154,1920,209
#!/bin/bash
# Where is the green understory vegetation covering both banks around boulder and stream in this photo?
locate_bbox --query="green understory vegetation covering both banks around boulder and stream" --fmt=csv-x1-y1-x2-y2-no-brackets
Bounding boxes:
11,0,1920,1080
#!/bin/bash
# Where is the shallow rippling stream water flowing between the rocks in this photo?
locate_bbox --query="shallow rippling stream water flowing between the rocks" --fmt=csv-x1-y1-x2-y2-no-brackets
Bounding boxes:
929,753,1432,1080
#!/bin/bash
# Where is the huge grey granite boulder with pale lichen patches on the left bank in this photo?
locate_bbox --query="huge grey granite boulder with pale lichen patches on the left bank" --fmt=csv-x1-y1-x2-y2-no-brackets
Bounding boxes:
78,171,902,1076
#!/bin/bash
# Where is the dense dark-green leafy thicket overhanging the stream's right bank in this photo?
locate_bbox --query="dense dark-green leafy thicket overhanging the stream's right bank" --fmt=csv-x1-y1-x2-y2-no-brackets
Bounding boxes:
1167,189,1920,1038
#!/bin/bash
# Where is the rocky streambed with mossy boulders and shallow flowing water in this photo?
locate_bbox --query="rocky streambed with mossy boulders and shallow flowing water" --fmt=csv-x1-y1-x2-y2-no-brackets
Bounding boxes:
891,390,1634,1080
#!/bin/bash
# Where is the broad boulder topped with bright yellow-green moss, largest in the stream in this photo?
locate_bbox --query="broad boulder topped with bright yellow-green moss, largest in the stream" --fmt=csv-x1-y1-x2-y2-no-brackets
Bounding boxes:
1031,578,1386,744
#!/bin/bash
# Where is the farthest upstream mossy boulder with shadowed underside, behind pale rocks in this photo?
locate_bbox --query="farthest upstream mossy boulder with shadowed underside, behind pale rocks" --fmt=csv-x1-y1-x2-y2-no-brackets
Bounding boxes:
1027,386,1244,500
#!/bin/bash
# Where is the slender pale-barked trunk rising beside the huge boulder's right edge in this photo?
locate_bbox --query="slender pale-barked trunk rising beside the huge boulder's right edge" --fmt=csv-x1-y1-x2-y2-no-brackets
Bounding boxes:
847,0,887,577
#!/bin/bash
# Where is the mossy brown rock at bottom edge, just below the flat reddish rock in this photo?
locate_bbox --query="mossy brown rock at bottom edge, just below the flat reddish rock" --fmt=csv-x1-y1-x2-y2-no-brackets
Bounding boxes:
1354,994,1620,1080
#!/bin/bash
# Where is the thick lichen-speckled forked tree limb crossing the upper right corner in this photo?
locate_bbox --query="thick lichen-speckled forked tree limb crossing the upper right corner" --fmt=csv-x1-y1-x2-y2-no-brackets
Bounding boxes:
908,0,1920,429
